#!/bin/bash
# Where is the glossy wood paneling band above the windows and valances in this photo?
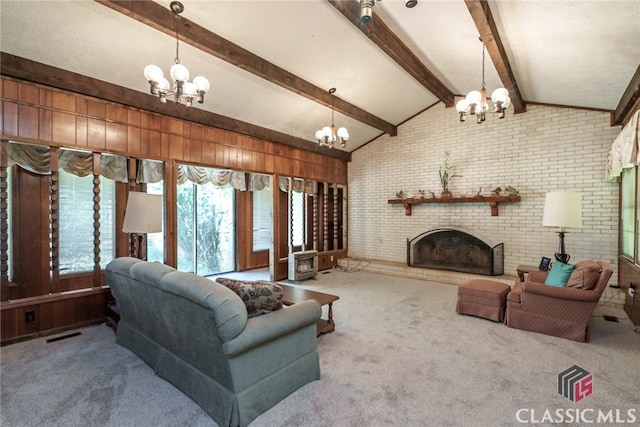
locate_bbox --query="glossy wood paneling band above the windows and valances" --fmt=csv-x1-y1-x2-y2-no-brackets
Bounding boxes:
1,77,347,184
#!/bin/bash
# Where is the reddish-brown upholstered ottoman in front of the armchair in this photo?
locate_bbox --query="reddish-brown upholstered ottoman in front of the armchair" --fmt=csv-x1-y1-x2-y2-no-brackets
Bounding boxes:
456,279,511,322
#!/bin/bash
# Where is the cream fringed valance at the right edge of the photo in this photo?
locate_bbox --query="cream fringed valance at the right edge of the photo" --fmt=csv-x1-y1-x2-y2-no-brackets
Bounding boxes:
606,111,640,181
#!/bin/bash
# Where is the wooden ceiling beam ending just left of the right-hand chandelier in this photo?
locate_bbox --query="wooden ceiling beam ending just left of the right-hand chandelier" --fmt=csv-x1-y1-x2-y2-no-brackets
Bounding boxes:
328,0,455,107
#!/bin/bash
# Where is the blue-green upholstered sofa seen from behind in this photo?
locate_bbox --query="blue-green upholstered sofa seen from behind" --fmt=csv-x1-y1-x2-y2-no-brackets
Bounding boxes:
106,257,321,426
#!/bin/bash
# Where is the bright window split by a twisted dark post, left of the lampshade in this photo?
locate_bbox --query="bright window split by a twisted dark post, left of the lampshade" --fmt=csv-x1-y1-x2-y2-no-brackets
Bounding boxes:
58,170,115,273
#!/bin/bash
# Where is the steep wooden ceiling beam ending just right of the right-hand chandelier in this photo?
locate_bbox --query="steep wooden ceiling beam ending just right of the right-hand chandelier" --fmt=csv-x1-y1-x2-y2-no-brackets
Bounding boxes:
464,0,527,114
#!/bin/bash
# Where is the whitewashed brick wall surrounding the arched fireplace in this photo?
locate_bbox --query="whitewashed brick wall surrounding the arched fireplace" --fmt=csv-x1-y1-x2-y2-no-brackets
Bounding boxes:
348,104,620,283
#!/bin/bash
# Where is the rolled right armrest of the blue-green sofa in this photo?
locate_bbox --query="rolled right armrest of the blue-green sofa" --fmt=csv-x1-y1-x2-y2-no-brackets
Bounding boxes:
223,300,322,357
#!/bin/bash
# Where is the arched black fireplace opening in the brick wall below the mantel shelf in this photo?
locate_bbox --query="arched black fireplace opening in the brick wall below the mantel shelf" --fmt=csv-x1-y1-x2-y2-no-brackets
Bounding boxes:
407,228,504,276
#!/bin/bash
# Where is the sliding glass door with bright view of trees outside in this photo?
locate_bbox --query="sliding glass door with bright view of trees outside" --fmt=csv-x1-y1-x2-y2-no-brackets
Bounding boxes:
177,181,235,276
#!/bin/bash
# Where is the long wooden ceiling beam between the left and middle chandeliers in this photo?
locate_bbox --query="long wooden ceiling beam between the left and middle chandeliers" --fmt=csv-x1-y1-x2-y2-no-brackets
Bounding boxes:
95,0,398,136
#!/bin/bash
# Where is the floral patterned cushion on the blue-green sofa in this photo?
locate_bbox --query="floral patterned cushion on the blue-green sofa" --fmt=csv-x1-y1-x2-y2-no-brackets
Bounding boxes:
216,277,284,317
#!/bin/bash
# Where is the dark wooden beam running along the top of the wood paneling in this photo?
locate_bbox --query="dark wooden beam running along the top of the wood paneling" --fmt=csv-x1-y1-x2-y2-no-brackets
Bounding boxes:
0,52,351,161
